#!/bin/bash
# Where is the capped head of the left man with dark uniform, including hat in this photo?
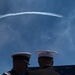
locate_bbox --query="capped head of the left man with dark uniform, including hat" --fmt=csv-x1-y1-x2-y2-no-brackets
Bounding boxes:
12,52,31,72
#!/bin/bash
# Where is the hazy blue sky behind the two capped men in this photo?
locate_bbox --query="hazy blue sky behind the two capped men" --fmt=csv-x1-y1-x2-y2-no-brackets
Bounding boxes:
0,0,75,73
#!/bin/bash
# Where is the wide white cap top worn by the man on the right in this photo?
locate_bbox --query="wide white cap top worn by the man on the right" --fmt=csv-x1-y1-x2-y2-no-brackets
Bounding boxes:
36,50,57,58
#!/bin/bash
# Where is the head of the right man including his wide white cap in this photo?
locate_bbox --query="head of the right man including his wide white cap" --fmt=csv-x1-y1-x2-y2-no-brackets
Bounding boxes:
36,50,57,68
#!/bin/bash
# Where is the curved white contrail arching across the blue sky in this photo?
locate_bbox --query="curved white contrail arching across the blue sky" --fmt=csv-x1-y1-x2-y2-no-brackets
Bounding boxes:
0,12,63,19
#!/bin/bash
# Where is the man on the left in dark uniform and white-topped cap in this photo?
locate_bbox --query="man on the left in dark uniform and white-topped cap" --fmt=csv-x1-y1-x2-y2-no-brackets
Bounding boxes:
3,52,31,75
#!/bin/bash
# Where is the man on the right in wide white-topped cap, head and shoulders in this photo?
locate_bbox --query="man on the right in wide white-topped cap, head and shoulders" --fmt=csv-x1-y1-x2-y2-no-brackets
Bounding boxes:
30,50,60,75
